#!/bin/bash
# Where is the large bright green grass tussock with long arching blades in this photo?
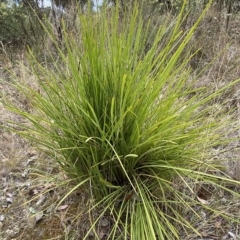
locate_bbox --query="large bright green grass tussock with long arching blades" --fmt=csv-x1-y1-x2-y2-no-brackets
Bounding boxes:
0,0,237,239
